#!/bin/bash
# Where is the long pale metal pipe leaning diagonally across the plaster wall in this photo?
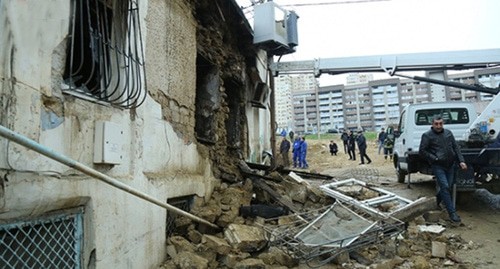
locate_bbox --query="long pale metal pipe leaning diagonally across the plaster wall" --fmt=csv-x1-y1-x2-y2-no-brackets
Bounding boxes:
0,125,220,229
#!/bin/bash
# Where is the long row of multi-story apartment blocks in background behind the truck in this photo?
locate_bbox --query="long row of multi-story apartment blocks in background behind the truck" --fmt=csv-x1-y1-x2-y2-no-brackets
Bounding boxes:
280,68,500,134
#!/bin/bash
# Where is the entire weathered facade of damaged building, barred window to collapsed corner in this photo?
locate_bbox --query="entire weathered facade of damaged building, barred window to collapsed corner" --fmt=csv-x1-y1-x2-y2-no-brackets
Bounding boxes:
0,0,272,268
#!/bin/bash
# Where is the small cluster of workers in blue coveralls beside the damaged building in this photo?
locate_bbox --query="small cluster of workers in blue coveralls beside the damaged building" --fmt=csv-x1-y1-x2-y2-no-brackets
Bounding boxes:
280,134,309,169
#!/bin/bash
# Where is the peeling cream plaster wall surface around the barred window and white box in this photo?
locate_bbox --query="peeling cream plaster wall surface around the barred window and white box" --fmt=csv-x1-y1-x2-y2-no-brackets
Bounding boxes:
0,0,241,268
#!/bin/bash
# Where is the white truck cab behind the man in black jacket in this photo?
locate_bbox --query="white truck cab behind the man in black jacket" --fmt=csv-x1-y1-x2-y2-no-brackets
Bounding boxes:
393,102,477,183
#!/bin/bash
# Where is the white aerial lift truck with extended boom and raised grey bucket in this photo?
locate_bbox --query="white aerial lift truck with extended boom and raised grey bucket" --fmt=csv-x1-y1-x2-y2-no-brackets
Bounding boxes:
254,2,500,188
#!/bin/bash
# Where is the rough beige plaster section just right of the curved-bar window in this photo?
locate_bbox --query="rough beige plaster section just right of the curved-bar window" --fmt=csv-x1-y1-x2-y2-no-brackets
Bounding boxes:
146,0,196,142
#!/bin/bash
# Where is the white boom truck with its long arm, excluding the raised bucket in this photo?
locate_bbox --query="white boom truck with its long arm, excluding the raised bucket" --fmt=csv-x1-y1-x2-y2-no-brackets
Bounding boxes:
271,49,500,190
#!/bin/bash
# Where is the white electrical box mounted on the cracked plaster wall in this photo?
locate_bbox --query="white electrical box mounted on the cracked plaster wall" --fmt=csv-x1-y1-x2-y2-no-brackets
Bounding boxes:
94,121,125,164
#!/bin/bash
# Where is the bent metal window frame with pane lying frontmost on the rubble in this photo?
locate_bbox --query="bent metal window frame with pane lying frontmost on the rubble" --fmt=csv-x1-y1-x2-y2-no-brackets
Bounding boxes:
260,201,404,267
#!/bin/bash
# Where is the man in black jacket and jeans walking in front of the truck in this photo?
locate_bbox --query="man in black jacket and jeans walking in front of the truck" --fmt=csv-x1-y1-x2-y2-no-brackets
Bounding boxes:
419,116,467,223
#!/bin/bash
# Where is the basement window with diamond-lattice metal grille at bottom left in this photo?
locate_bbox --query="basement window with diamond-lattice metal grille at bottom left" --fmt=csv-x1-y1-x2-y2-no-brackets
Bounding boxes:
0,210,83,269
